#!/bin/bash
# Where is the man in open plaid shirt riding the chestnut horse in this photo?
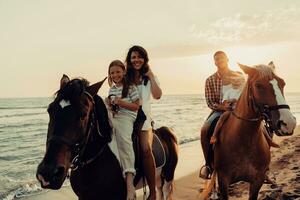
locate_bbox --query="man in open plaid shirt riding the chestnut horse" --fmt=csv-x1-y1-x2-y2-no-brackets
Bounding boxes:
200,51,245,179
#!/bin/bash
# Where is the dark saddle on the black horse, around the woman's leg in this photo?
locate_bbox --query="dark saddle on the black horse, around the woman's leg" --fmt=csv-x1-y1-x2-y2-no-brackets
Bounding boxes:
132,107,166,185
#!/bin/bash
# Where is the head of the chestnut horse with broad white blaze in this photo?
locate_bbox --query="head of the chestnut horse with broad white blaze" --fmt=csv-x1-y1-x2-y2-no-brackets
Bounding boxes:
239,62,296,136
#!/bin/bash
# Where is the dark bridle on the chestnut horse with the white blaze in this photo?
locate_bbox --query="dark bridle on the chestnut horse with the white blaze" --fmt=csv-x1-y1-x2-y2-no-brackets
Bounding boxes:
231,84,290,133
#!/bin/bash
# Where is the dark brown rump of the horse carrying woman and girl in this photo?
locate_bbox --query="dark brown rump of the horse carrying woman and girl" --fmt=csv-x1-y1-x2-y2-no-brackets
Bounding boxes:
155,126,178,182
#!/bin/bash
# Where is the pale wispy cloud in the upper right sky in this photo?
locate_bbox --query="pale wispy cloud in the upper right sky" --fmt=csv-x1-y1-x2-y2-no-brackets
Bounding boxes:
189,7,300,44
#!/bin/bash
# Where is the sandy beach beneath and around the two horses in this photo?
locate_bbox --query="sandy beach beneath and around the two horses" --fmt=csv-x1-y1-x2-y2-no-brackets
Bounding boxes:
22,125,300,200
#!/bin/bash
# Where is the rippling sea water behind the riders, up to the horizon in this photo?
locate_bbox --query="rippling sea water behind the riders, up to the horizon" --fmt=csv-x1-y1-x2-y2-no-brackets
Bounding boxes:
0,93,300,200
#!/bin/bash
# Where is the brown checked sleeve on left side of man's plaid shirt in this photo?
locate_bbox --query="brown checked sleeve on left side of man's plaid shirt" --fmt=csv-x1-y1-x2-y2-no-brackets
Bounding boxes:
205,72,222,111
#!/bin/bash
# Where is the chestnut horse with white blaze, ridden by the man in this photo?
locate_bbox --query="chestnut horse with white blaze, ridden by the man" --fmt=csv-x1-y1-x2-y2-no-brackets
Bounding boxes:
202,62,296,199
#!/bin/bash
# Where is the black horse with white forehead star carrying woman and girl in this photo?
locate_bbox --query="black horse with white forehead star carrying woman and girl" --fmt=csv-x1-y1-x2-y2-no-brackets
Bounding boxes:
36,75,178,200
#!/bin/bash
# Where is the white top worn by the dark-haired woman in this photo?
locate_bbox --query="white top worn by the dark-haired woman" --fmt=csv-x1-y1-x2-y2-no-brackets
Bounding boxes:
137,76,159,130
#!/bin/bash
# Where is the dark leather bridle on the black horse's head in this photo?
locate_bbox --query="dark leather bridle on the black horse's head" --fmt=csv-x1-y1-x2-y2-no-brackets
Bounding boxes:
47,91,107,171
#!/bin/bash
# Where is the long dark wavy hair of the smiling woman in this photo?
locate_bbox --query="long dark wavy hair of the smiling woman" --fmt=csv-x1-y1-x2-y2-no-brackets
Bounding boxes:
125,45,149,84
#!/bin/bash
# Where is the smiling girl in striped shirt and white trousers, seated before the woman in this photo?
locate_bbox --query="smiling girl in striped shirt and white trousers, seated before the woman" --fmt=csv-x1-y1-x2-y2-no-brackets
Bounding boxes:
107,60,139,200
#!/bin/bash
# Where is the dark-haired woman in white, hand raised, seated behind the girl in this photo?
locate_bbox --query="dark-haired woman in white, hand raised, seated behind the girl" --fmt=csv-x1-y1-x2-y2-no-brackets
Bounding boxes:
126,46,162,200
